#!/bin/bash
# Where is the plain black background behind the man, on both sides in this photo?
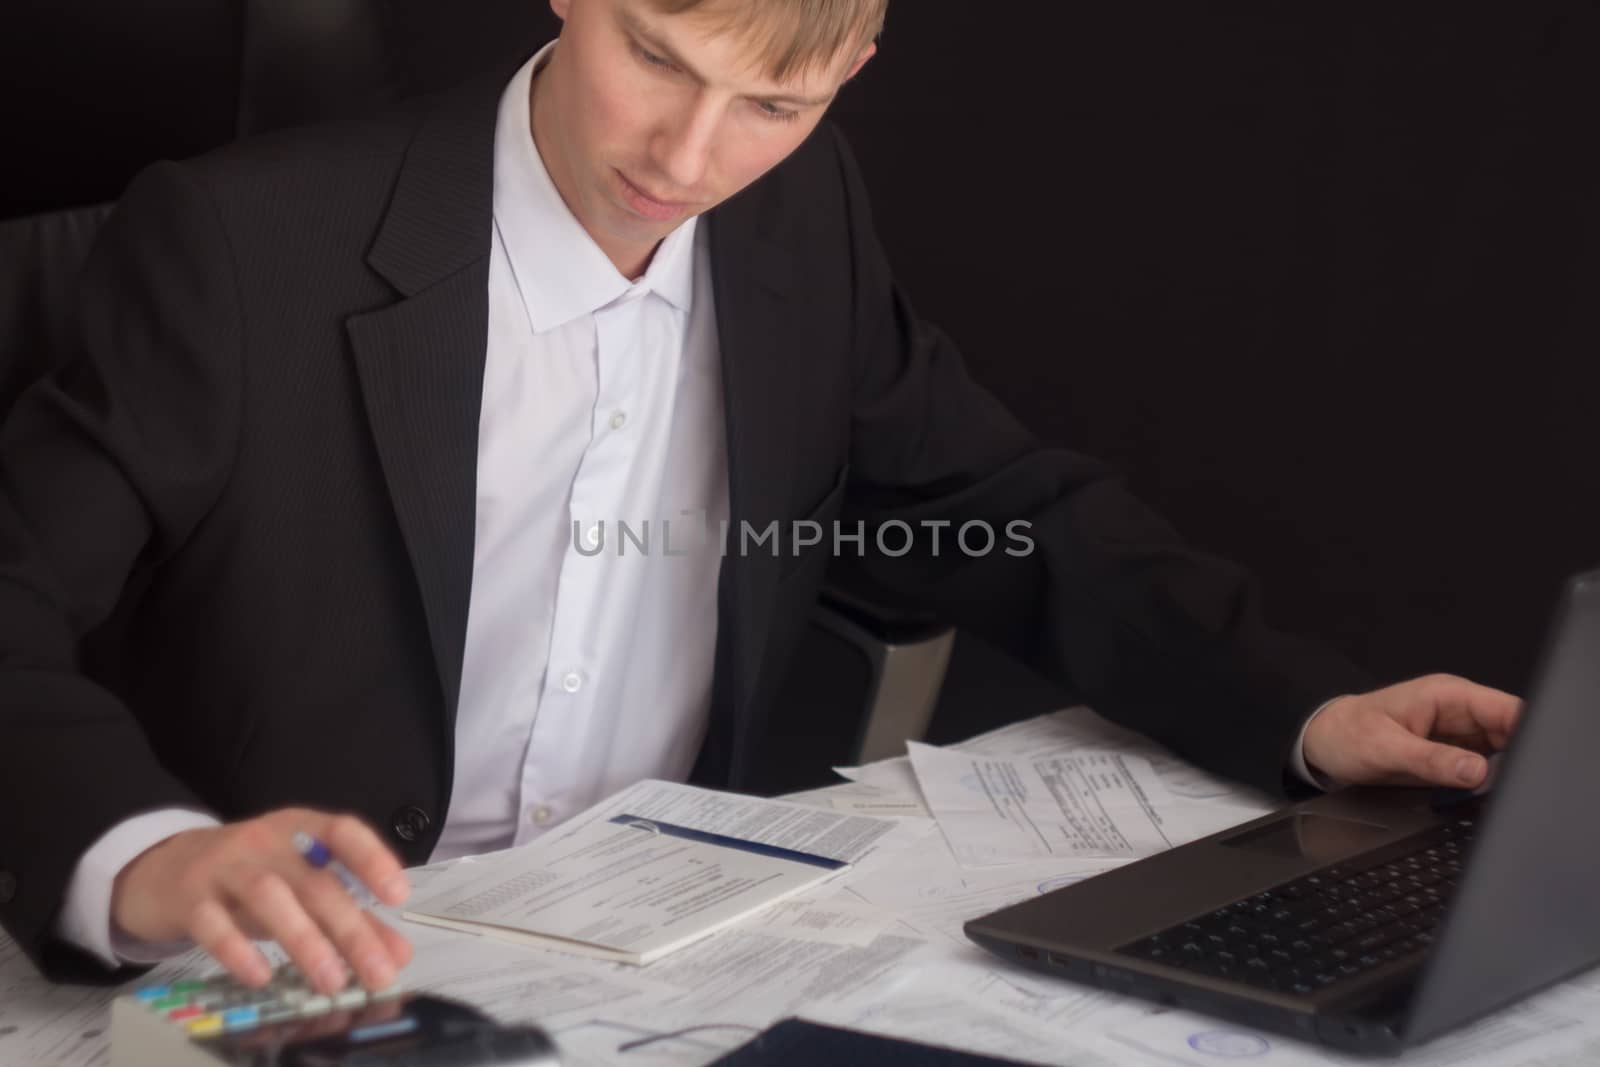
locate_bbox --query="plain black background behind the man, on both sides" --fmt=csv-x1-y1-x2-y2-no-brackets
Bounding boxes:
0,0,1600,689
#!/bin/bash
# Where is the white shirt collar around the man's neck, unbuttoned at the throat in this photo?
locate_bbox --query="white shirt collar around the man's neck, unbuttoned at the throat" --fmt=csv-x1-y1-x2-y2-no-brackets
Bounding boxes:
494,42,699,333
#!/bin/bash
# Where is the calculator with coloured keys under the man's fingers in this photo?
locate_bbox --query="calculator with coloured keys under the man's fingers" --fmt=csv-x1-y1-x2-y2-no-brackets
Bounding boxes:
110,965,560,1067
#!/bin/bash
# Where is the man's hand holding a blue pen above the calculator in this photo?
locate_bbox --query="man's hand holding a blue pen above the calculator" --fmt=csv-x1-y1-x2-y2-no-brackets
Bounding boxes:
110,808,411,993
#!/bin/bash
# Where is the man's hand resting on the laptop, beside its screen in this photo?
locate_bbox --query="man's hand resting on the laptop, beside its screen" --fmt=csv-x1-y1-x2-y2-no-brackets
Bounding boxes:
1304,675,1522,789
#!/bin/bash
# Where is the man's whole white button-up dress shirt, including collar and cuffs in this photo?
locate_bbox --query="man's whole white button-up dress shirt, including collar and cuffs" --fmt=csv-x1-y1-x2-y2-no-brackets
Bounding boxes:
58,43,1320,966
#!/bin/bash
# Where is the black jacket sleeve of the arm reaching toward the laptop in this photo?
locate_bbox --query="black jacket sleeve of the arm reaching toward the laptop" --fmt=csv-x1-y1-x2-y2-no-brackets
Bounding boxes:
834,123,1373,792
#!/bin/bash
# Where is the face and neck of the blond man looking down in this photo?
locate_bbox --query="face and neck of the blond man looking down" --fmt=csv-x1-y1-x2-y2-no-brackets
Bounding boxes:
533,0,872,272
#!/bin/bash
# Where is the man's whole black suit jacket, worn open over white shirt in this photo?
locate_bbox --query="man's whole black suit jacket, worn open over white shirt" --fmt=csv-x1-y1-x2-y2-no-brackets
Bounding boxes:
0,58,1366,973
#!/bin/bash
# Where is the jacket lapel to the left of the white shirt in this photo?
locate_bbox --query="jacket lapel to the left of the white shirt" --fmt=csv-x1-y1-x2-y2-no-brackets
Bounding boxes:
346,70,510,729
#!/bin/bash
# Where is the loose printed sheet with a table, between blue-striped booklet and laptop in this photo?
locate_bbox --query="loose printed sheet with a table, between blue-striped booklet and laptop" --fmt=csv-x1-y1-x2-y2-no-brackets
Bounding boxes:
907,742,1187,867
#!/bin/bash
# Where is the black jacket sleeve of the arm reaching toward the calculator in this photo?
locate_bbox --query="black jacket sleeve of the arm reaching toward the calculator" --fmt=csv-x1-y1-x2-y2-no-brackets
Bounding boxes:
0,163,242,976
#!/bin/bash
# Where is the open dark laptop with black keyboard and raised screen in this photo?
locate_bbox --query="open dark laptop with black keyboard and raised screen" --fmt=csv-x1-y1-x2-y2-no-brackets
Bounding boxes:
966,571,1600,1053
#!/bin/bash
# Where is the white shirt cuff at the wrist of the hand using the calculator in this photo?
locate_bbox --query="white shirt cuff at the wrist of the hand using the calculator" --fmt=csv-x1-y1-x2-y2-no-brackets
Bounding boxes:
56,808,221,969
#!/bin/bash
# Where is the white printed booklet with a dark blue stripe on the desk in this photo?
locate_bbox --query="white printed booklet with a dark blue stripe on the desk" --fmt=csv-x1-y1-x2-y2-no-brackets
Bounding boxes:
405,781,898,965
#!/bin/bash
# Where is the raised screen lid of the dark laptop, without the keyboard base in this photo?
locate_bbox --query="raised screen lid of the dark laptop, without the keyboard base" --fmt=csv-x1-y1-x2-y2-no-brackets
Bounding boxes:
1405,571,1600,1041
